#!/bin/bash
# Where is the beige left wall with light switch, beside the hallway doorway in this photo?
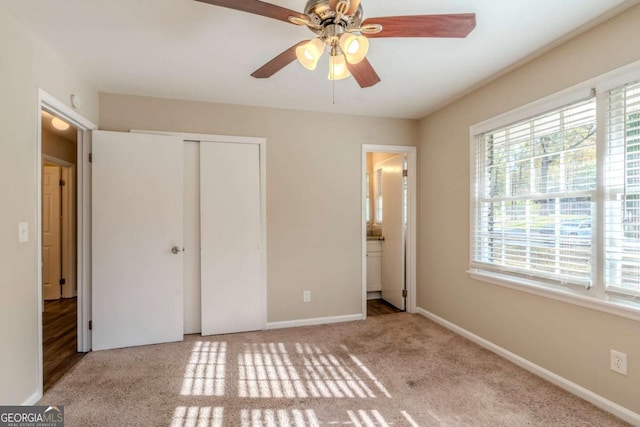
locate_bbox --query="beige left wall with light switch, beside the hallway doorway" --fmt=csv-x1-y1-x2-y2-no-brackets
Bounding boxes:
0,7,98,404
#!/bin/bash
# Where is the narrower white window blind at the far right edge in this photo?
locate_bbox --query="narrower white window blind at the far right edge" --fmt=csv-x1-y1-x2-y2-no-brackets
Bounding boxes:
604,82,640,297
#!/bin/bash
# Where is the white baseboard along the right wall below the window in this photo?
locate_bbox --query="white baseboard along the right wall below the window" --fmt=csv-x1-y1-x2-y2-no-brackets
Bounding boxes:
416,308,640,426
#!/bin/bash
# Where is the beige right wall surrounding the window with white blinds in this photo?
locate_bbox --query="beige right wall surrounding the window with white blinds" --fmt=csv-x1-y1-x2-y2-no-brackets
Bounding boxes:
418,6,640,413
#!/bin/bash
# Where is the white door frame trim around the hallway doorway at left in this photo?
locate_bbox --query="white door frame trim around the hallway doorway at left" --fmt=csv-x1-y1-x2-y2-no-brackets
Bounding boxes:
34,88,98,397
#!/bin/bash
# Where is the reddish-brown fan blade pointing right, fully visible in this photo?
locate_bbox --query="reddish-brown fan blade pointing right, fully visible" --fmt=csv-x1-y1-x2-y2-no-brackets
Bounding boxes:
362,13,476,38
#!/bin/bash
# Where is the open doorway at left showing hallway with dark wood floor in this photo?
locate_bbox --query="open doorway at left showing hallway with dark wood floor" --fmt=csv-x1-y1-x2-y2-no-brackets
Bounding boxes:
40,110,84,391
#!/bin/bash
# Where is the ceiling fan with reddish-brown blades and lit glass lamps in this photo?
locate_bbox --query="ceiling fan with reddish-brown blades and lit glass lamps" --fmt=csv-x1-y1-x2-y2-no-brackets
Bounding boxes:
196,0,476,88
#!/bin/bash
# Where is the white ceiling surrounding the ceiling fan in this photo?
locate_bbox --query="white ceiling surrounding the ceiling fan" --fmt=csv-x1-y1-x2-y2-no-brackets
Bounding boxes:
0,0,638,118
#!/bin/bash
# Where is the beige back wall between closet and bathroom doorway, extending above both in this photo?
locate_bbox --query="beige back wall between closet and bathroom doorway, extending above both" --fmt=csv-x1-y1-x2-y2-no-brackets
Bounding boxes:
100,94,418,322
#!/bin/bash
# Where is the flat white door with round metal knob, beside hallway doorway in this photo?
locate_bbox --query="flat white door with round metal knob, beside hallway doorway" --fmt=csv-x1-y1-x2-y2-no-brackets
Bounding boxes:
92,131,184,350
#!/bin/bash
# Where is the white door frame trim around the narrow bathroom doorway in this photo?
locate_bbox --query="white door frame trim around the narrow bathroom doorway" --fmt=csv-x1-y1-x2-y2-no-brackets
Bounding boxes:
361,144,418,319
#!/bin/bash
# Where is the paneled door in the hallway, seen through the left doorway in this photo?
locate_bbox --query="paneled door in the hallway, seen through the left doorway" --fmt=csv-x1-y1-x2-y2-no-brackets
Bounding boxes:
42,166,61,300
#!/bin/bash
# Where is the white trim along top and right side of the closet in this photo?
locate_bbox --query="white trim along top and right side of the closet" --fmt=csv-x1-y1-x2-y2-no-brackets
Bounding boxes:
130,129,268,330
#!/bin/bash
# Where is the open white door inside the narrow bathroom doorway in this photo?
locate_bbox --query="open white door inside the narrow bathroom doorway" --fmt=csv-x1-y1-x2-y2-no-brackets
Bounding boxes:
374,154,405,310
